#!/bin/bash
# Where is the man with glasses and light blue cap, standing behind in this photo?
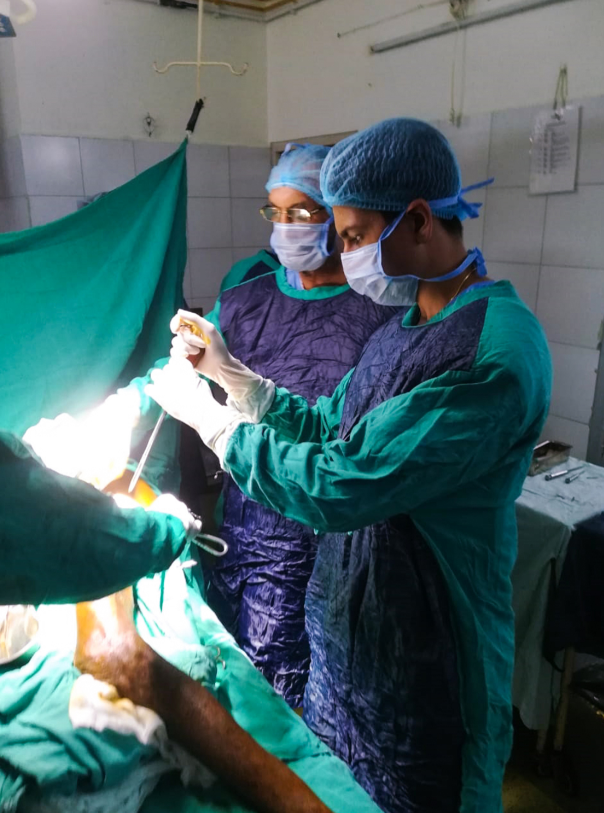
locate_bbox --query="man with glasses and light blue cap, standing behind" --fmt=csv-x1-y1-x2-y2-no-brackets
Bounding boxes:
181,144,396,708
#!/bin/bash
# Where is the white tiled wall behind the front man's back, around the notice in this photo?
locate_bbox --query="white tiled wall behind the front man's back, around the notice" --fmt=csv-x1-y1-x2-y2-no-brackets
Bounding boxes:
437,106,604,464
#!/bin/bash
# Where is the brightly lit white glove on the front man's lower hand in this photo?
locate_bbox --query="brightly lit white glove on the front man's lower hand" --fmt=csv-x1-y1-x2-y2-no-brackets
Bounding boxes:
145,359,252,465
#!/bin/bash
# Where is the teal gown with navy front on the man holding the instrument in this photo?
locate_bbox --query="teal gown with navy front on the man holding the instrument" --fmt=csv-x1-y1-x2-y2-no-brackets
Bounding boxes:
219,282,551,813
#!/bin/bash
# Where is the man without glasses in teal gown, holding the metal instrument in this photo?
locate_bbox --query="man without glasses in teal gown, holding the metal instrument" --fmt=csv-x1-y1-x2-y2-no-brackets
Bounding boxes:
149,119,551,813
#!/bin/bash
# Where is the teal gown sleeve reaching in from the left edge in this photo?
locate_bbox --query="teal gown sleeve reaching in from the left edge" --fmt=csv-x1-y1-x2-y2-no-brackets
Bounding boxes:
0,432,187,604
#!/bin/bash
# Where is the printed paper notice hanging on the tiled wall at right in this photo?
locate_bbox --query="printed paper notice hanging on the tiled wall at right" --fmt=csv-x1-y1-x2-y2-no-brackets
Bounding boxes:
529,105,580,195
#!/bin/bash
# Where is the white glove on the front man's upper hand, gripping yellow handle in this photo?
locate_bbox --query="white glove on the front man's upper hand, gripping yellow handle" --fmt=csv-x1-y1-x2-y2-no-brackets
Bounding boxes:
170,310,275,423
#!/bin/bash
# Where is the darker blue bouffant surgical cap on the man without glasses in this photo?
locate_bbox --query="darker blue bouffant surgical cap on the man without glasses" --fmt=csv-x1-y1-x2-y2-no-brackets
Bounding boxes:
321,118,489,220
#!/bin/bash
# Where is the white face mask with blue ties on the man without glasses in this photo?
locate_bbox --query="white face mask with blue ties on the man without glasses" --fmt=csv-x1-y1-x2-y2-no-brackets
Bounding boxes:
342,212,486,305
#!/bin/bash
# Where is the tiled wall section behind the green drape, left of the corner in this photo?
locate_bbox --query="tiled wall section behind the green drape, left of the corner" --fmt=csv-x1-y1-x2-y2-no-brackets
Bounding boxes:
0,136,270,312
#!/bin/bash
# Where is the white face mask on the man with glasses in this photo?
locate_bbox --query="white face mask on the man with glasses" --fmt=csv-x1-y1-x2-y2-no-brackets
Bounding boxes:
271,218,333,272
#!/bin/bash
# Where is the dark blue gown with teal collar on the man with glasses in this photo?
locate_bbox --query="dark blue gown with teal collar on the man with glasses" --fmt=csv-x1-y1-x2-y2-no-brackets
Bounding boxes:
208,251,398,708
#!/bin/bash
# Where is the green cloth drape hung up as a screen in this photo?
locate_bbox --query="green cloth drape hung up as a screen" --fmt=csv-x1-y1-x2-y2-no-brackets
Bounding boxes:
0,142,187,488
